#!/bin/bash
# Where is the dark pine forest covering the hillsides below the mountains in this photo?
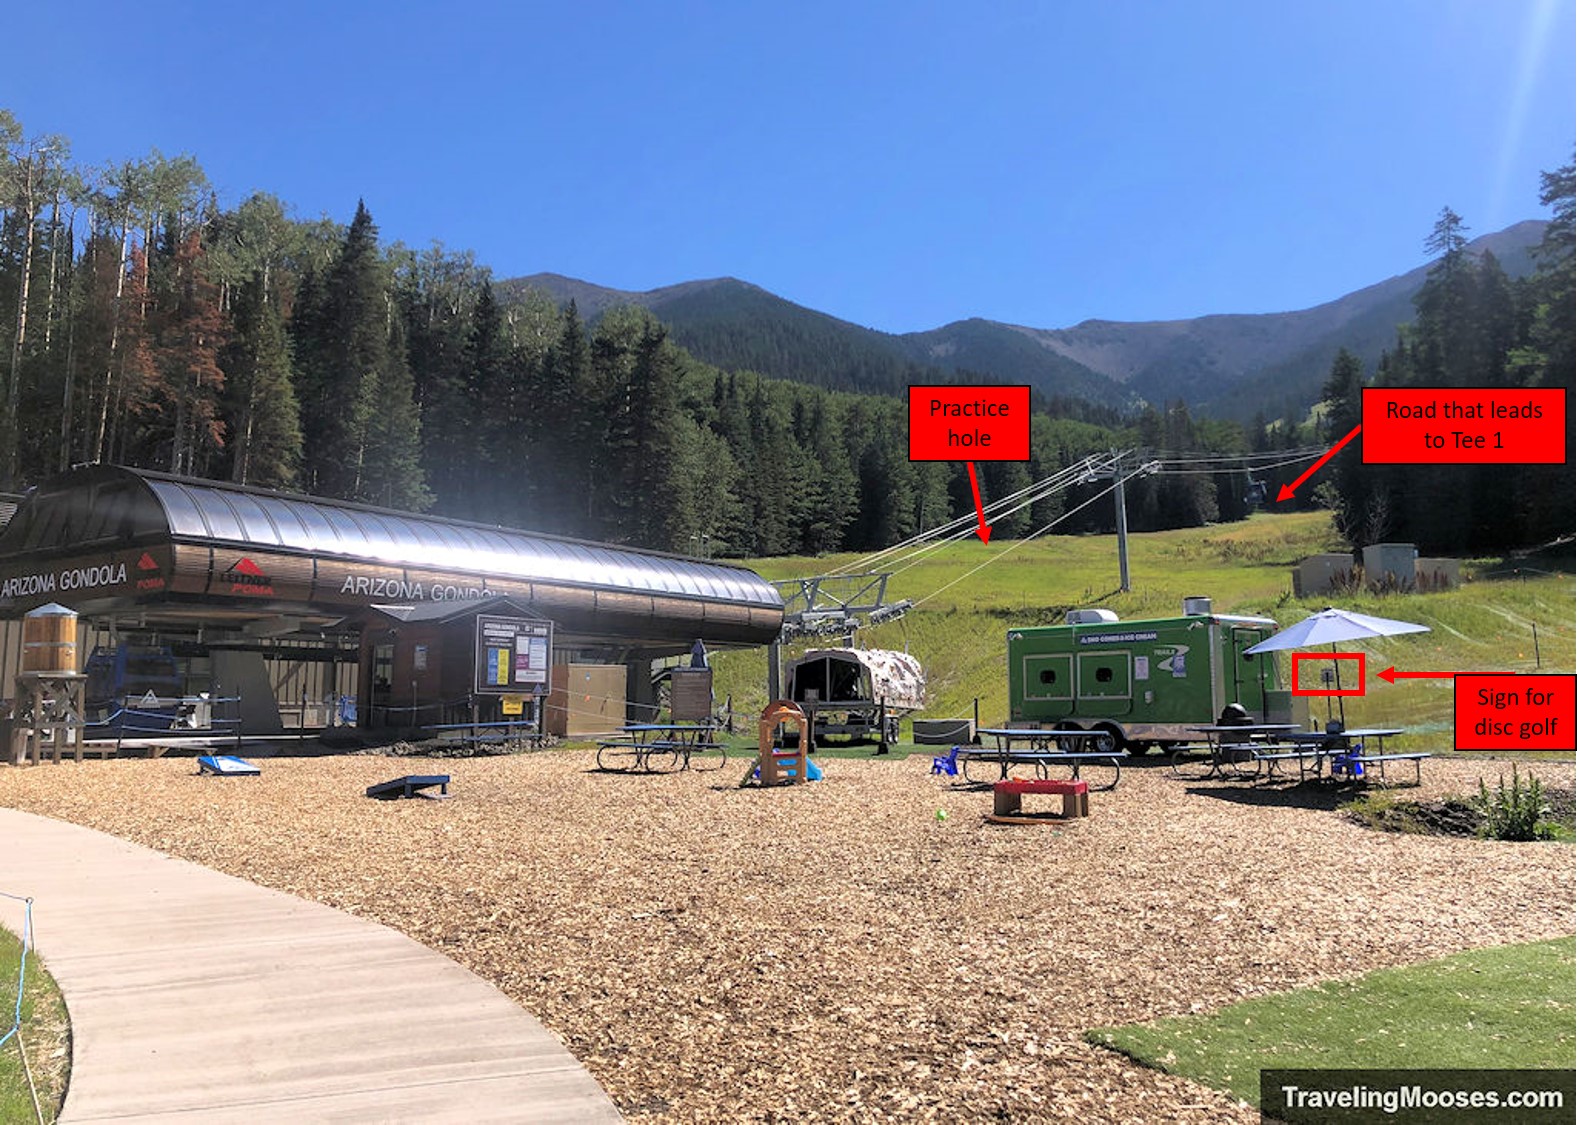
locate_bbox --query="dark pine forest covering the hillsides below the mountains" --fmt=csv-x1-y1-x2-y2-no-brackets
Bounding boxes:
0,109,1574,555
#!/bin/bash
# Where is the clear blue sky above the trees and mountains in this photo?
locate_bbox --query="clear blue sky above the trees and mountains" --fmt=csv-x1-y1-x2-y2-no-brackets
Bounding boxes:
0,0,1577,331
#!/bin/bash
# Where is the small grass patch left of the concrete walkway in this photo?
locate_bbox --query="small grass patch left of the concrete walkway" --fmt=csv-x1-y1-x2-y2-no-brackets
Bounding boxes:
0,929,71,1122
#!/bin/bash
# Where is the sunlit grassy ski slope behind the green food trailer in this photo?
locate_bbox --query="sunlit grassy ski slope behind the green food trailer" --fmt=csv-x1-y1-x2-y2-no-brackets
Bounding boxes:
714,513,1577,753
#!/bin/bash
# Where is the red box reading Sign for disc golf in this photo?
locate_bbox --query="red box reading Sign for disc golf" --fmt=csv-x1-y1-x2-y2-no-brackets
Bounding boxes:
1456,674,1577,749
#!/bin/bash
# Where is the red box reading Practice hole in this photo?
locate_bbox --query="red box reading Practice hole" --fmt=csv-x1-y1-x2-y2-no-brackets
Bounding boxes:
908,385,1030,461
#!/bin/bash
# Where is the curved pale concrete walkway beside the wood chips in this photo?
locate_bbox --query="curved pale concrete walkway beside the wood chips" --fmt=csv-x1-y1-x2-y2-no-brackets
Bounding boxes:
0,809,618,1123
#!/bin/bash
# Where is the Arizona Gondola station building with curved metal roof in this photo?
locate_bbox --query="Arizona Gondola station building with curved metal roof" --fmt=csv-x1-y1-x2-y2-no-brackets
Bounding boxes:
0,465,784,734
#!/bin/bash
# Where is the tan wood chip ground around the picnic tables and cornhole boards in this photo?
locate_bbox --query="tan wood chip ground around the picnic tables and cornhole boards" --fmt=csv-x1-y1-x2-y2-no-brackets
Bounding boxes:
0,751,1574,1122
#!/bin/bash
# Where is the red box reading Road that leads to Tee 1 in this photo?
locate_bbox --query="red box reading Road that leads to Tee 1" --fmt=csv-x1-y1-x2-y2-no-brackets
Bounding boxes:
1364,387,1568,465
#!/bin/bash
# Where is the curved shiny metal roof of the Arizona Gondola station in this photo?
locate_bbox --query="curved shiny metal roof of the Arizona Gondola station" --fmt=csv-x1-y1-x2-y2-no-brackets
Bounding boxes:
0,465,782,609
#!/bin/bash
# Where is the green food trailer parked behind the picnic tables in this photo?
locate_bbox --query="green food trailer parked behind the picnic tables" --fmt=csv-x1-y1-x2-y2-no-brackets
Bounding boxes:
1008,598,1295,753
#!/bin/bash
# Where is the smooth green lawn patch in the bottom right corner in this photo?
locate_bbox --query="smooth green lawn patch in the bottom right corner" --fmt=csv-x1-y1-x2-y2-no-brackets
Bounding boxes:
1087,937,1577,1104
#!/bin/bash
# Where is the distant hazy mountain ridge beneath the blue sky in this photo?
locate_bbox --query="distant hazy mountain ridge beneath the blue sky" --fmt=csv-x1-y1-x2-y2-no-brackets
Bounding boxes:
498,219,1544,420
